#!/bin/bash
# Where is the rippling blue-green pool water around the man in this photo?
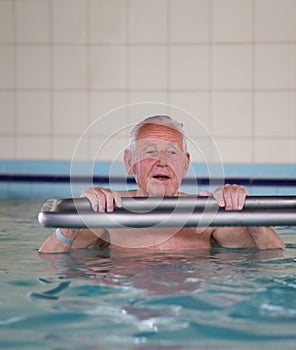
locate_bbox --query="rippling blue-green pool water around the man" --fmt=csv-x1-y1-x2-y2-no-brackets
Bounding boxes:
0,200,296,350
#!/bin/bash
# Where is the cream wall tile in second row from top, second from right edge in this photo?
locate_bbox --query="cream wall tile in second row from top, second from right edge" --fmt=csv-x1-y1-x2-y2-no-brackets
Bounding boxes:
212,45,252,89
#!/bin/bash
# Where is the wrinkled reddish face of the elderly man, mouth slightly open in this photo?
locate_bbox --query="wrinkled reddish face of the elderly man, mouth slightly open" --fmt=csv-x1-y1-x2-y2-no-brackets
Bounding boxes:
126,124,190,196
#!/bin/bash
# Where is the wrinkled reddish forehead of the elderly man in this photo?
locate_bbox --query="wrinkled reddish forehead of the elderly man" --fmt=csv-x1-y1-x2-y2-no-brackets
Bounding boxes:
135,123,183,151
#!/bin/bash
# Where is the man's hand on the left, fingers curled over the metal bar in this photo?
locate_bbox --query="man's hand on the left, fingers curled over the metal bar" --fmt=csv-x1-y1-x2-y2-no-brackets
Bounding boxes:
80,187,122,212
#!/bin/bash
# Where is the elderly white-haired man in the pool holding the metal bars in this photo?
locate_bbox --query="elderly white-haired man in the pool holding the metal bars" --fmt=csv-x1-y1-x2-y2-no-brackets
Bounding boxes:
39,116,285,253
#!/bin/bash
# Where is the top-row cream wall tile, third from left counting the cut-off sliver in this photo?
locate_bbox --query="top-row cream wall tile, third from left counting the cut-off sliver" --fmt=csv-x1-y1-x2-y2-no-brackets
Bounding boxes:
52,0,87,43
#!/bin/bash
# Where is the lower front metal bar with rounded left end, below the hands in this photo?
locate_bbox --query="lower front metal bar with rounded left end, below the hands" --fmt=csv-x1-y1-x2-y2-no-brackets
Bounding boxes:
38,209,296,228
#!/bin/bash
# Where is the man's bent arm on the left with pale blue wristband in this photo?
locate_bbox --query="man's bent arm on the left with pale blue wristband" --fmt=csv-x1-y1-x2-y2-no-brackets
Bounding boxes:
39,228,105,254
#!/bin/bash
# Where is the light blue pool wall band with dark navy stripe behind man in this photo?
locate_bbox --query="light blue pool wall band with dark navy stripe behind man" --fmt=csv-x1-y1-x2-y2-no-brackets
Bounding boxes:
0,160,296,199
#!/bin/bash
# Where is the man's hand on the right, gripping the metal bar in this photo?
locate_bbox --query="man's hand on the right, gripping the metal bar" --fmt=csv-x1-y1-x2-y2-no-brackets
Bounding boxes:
200,184,248,210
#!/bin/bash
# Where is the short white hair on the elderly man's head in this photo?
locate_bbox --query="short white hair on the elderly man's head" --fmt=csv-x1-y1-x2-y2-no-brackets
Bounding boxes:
129,115,187,152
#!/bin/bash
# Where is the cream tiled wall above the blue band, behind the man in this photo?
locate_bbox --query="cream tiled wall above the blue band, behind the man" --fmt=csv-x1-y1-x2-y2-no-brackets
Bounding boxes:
0,0,296,164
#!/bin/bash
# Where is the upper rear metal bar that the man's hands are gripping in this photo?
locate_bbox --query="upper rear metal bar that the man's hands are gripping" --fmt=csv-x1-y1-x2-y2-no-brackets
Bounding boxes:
52,196,296,212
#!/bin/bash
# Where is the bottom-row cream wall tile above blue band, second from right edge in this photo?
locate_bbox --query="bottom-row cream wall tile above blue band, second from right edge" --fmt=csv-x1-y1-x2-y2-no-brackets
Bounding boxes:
215,137,253,163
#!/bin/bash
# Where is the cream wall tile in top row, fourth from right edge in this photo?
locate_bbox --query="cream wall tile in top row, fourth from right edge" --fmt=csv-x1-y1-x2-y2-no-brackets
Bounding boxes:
128,0,168,43
